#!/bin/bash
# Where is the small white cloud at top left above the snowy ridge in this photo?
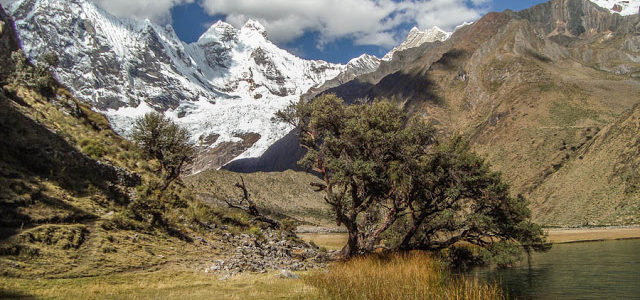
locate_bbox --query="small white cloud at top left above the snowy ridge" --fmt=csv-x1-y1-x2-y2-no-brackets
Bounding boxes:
92,0,194,25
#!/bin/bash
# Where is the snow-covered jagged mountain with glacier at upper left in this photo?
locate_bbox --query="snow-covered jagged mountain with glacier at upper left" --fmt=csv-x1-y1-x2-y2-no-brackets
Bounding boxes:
3,0,356,171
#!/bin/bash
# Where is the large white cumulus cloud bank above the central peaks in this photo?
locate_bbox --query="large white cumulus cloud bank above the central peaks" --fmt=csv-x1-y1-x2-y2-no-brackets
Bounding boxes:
201,0,491,47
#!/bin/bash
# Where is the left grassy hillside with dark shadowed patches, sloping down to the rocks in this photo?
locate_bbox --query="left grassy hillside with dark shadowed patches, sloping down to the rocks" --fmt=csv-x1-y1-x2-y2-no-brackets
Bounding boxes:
0,9,250,278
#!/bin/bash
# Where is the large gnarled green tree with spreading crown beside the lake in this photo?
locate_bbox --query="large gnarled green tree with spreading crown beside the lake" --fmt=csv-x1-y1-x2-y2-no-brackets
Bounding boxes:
276,94,545,256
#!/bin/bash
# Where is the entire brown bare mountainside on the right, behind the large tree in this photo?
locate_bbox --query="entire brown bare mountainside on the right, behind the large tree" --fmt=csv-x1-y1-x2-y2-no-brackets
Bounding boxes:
318,0,640,225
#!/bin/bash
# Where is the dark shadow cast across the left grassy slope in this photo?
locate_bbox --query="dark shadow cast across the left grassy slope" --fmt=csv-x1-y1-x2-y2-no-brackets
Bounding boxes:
0,90,139,240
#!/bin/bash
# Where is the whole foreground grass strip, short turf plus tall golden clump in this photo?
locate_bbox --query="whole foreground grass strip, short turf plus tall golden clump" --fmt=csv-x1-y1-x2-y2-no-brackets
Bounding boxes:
0,252,504,300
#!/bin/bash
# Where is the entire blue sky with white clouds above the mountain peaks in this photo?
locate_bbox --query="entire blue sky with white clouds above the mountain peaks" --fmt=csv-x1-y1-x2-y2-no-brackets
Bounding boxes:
94,0,544,63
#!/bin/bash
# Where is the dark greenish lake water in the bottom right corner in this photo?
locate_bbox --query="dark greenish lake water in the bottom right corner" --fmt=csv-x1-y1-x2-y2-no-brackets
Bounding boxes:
472,240,640,299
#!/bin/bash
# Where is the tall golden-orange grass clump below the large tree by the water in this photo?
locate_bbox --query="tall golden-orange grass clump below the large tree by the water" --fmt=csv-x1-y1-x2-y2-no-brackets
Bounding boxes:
303,252,504,300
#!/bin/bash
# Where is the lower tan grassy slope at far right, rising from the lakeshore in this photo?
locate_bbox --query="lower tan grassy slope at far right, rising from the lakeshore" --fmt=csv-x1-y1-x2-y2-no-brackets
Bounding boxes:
532,105,640,225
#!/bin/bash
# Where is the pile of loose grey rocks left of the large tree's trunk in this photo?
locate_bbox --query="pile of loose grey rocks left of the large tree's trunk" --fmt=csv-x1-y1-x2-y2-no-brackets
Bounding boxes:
205,229,335,279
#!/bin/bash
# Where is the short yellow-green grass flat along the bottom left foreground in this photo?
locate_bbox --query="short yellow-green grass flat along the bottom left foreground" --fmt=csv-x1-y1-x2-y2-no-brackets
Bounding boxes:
0,269,316,300
